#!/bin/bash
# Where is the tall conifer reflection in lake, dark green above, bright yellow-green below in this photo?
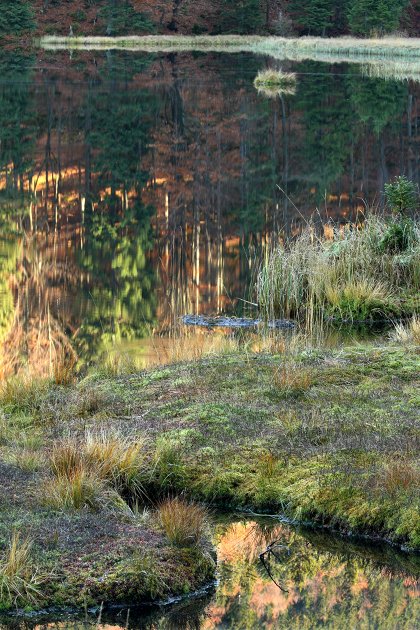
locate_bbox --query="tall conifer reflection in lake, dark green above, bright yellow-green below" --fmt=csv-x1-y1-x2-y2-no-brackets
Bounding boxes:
74,56,156,366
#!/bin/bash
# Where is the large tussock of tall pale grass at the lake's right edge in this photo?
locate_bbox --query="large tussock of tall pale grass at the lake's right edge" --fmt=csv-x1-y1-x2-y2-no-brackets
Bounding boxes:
256,216,420,328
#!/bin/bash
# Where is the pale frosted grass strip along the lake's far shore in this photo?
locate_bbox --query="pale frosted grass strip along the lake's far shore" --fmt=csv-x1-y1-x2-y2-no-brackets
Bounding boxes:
40,35,420,80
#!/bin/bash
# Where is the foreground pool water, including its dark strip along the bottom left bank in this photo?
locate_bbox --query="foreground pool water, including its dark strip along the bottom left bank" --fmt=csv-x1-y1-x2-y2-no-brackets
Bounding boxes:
4,516,420,630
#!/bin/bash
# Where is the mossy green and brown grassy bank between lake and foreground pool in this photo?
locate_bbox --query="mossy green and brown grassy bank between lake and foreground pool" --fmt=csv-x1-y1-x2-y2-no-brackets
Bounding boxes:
0,331,420,607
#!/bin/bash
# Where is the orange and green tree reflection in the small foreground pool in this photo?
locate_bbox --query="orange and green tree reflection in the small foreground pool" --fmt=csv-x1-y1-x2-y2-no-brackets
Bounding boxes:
201,521,420,628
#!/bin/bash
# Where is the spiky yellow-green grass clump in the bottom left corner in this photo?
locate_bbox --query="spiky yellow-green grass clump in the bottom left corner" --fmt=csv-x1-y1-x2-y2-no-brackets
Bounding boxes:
0,532,47,607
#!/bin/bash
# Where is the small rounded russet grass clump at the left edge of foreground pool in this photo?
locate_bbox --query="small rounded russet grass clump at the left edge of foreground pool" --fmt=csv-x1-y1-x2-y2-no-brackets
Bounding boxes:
158,497,208,547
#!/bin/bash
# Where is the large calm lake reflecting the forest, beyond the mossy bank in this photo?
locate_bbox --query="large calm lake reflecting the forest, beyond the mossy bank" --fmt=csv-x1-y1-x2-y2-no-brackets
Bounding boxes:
0,50,420,377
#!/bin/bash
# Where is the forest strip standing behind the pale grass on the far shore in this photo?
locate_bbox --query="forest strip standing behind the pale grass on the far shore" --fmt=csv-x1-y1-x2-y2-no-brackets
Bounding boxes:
0,0,420,38
